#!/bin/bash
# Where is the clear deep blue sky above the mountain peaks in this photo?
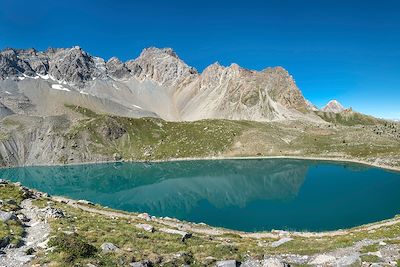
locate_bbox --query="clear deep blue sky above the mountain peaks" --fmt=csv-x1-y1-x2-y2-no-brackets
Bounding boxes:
0,0,400,118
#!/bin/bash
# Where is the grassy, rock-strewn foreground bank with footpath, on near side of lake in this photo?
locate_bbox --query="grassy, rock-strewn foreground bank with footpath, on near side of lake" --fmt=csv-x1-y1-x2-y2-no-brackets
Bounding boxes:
0,180,400,267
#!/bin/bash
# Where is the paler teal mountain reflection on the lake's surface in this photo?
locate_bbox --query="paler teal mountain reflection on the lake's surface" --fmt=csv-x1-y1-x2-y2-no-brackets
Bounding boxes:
1,160,308,215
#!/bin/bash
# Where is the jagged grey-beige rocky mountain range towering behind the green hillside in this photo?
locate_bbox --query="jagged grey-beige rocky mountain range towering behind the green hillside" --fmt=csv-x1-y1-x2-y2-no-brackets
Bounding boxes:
0,47,318,121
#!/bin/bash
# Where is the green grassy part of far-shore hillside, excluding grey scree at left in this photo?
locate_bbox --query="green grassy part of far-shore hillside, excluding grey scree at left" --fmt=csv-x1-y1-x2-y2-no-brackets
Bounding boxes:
65,104,400,166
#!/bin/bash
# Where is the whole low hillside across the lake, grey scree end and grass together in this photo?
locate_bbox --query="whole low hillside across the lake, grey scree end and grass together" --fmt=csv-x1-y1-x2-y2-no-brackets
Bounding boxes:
0,106,400,170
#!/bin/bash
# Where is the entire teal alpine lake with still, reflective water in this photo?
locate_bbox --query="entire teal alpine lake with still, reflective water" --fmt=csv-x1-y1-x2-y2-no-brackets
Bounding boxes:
0,159,400,231
